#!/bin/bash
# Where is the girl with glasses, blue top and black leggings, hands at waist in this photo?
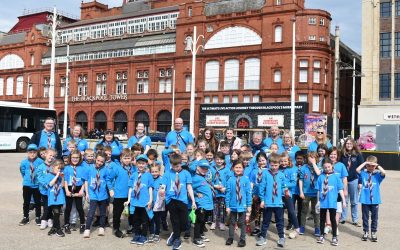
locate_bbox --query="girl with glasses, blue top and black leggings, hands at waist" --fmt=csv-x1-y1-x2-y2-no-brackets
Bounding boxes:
64,150,87,234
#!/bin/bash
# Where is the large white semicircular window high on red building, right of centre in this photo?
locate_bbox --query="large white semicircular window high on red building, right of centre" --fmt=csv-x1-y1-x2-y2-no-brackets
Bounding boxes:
205,26,262,49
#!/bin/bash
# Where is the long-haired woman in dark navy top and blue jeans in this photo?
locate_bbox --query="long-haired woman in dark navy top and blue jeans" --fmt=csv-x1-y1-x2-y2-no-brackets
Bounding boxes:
340,138,364,227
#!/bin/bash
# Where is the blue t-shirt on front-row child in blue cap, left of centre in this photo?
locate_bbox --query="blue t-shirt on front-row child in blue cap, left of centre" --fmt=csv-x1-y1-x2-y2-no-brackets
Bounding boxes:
128,172,154,208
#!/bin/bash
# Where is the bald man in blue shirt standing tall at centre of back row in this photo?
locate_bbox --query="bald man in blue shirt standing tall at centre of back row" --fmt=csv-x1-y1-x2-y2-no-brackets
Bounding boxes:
165,118,194,152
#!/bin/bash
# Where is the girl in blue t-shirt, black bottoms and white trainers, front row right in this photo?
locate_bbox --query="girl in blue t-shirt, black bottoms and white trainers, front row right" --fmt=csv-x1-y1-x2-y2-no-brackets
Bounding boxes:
316,160,346,246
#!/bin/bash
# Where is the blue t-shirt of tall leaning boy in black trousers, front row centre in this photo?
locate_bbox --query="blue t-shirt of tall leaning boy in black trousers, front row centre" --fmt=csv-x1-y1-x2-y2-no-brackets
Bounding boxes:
162,169,192,204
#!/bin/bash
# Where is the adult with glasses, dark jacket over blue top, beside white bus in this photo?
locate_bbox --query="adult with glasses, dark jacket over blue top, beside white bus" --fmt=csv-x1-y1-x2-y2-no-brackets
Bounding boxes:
29,117,62,158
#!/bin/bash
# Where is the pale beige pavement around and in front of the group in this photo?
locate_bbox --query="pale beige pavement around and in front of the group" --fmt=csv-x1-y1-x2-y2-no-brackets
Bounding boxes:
0,153,400,250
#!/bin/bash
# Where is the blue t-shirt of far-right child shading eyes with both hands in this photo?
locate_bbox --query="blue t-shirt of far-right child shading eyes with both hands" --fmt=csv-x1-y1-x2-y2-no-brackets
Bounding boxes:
359,169,385,205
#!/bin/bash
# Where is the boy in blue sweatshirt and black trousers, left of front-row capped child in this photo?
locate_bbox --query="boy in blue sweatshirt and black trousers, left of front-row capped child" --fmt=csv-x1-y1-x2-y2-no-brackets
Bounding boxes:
110,148,136,238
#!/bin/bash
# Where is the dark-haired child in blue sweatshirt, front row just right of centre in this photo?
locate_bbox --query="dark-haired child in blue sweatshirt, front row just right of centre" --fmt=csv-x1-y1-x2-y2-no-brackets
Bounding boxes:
225,160,251,247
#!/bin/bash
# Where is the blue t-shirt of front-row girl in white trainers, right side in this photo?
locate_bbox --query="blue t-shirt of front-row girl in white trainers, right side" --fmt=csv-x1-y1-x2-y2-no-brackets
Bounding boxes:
316,173,343,209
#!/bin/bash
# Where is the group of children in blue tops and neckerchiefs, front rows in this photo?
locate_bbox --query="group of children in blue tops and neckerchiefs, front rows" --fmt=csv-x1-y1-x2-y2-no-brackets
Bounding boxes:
20,140,385,249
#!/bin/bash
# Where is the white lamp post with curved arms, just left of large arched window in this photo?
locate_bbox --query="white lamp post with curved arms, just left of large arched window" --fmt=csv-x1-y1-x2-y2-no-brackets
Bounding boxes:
185,26,204,135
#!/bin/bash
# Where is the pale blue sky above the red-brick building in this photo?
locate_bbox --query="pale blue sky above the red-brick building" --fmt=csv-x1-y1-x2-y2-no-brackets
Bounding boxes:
0,0,361,53
